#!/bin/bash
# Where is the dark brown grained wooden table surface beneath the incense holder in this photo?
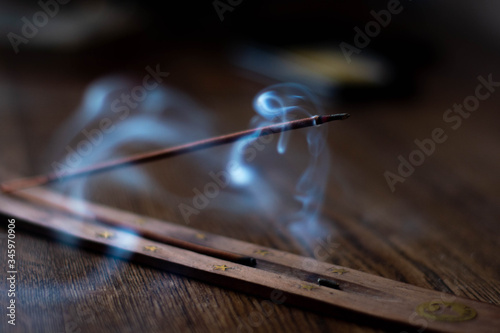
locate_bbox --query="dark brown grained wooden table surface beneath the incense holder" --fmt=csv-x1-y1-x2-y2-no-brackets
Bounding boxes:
0,39,500,332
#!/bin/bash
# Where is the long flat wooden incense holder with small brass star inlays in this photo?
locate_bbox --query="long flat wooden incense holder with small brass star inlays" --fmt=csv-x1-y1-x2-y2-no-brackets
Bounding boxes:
0,188,500,332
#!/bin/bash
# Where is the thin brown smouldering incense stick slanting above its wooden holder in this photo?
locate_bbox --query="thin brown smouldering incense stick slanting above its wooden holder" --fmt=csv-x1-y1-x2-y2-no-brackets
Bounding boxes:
0,113,349,193
